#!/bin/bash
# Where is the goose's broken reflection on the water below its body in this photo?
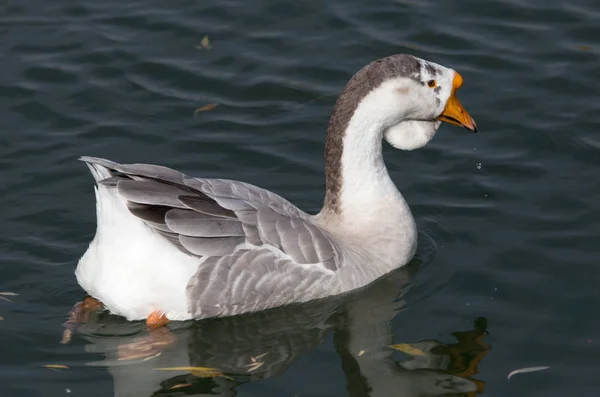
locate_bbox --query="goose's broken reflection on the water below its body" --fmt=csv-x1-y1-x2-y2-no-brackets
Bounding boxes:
67,255,490,397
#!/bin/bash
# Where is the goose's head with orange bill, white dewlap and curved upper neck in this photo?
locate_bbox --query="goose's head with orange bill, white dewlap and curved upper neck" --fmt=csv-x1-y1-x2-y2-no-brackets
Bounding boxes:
328,54,477,154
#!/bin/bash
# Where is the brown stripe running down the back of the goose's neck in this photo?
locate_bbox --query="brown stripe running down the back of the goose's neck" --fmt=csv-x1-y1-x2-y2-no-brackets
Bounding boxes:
323,54,423,214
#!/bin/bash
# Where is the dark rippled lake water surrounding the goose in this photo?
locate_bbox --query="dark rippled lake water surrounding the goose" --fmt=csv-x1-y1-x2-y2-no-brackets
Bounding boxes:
0,0,600,397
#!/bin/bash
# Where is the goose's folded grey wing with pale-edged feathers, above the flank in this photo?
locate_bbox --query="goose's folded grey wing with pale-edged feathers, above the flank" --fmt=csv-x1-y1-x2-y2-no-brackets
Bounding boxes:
82,157,340,270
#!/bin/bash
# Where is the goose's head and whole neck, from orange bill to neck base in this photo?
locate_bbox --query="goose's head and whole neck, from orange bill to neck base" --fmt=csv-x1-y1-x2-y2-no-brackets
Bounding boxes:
323,54,477,218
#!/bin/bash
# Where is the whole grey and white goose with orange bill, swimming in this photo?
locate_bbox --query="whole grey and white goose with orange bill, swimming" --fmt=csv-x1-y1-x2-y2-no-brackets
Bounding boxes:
75,54,477,328
